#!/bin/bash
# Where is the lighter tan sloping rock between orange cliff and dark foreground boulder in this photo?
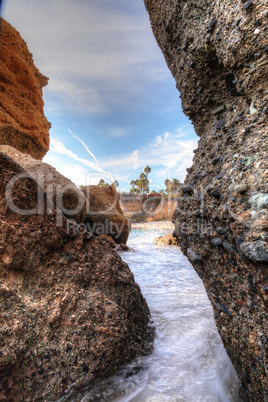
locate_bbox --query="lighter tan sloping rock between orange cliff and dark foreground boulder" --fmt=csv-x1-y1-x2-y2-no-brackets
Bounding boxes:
0,145,88,223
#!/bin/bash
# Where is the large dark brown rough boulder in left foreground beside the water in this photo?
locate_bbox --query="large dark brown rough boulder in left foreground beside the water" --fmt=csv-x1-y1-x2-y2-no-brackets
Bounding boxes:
0,153,149,401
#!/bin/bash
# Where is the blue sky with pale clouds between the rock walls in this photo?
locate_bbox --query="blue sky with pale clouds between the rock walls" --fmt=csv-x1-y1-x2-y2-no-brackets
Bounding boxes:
1,0,197,191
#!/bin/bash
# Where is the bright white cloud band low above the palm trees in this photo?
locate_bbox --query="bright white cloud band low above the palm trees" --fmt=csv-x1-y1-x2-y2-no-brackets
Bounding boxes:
44,127,197,188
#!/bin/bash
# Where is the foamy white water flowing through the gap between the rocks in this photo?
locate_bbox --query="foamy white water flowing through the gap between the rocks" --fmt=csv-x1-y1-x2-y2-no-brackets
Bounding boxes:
76,230,241,402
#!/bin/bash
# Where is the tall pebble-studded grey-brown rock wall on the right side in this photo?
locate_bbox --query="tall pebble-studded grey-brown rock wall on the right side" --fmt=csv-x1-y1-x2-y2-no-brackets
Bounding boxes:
145,0,268,401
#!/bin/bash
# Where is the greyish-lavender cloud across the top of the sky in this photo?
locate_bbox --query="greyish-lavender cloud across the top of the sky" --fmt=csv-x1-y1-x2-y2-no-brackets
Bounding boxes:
4,0,167,116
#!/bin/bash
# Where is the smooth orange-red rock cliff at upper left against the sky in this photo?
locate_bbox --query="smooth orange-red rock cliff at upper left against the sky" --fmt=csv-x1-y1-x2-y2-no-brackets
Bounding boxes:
0,17,50,159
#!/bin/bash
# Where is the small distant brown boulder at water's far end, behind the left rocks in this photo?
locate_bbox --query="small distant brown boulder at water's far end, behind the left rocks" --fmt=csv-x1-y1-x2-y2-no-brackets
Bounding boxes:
83,186,130,244
